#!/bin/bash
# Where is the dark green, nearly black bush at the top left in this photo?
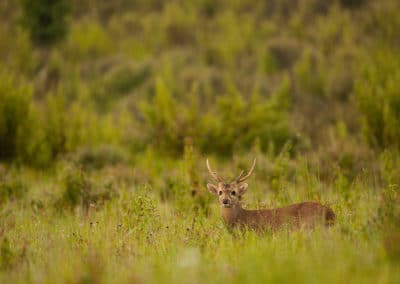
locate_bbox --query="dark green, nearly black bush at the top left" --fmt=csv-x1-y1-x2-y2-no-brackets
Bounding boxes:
20,0,71,45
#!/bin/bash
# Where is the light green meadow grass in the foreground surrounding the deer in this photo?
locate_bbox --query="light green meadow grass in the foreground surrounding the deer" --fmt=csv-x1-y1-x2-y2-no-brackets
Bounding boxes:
0,155,400,283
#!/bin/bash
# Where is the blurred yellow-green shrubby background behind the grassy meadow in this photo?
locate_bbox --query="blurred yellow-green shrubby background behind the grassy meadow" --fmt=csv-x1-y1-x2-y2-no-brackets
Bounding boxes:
0,0,400,178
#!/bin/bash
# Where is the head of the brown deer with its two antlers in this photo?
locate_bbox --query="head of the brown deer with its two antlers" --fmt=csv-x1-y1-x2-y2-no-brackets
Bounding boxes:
207,159,256,208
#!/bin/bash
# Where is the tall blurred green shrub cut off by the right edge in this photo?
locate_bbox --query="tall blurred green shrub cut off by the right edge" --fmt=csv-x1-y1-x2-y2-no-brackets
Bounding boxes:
355,50,400,149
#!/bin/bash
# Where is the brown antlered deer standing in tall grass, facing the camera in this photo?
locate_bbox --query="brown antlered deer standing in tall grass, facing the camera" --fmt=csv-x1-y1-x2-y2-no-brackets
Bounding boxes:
207,159,336,231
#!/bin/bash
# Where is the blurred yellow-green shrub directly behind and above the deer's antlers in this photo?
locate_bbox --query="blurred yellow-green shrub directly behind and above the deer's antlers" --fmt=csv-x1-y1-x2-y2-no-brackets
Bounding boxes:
199,78,296,155
